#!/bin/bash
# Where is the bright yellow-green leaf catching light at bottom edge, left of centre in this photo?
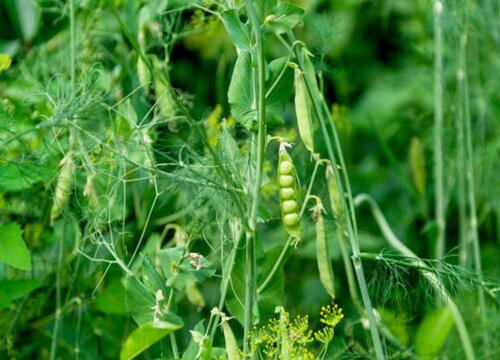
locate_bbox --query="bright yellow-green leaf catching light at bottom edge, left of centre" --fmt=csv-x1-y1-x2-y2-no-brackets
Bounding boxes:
120,321,182,360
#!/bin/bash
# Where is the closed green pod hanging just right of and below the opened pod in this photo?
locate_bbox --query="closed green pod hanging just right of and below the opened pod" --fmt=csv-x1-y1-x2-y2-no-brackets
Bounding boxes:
312,198,335,299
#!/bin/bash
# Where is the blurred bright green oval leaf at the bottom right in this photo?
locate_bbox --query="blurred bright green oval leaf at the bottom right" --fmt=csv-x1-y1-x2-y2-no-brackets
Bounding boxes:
415,307,454,360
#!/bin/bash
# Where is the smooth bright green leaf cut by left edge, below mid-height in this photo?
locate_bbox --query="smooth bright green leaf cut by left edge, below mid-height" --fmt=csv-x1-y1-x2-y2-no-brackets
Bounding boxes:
0,223,31,270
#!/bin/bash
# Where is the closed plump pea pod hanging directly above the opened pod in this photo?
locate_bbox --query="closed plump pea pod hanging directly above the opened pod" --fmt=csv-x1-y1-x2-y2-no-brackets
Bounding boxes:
295,67,314,153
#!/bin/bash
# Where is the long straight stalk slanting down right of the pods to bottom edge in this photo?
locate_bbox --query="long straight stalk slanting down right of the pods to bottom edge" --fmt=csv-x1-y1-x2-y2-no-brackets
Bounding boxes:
289,33,385,360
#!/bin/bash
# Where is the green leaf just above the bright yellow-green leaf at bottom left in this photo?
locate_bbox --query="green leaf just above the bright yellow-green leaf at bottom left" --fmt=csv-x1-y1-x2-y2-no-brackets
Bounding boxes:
124,276,156,325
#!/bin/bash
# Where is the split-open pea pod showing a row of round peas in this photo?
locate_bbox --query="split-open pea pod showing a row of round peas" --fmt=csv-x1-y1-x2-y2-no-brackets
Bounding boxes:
278,143,300,240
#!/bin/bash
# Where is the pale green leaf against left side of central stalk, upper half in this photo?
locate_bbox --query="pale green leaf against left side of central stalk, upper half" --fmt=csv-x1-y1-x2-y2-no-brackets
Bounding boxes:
227,51,257,129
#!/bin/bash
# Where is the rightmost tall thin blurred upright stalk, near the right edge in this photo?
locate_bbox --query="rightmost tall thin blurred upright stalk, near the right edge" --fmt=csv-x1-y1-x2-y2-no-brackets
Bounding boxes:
460,31,490,354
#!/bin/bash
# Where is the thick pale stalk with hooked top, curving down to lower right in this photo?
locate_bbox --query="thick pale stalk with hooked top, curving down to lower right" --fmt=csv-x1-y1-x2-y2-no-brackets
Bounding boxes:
354,194,475,360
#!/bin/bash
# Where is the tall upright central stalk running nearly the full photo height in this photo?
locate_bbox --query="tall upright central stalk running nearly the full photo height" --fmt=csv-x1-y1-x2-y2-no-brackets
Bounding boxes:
243,0,266,353
